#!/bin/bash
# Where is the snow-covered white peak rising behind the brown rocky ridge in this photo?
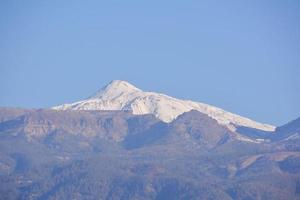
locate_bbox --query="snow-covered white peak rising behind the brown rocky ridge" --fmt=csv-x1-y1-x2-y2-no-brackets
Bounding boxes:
53,80,275,131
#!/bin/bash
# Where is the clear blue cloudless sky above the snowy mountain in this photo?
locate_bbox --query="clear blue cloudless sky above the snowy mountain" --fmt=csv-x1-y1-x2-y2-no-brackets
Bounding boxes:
0,0,300,125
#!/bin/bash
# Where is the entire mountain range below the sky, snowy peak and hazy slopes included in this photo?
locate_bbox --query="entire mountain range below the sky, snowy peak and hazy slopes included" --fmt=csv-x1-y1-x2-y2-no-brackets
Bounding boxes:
0,81,300,200
